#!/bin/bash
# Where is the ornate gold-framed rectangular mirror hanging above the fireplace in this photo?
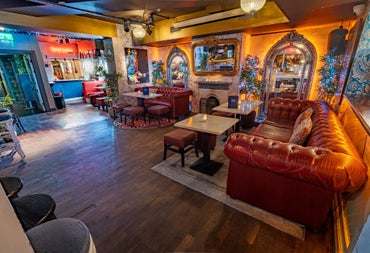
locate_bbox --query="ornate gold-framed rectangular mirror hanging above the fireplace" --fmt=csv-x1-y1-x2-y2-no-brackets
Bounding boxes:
192,37,240,76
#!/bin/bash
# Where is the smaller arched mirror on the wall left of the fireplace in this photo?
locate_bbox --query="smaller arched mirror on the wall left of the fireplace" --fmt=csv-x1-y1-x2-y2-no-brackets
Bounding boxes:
166,46,189,88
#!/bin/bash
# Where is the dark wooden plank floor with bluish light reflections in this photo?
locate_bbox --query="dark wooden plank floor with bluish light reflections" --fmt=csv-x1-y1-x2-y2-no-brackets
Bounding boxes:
0,104,333,253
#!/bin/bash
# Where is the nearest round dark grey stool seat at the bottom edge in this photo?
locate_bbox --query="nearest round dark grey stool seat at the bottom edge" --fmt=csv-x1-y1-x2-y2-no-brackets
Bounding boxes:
26,218,96,253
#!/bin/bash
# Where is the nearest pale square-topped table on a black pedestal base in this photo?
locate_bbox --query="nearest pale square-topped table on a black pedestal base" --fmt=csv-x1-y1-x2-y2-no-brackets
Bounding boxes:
174,113,239,176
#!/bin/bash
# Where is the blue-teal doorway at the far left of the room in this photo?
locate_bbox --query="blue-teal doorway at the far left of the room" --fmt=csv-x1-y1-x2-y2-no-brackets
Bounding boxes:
0,53,43,116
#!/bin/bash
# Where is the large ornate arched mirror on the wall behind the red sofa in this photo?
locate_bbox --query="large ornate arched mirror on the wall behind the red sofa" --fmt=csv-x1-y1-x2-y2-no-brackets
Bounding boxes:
263,31,317,109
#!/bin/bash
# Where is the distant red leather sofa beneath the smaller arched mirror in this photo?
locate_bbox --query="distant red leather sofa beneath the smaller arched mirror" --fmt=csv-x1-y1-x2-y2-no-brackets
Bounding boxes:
135,86,193,118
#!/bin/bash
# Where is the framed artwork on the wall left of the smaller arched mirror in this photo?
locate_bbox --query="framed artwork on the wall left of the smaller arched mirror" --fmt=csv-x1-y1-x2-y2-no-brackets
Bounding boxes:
125,48,149,84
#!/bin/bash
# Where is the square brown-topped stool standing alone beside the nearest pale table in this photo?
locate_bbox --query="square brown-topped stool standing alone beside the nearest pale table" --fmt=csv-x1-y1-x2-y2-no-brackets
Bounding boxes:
163,128,199,167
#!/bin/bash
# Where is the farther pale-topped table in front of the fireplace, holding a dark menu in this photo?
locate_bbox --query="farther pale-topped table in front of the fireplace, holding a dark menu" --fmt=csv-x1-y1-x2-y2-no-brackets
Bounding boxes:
212,100,263,132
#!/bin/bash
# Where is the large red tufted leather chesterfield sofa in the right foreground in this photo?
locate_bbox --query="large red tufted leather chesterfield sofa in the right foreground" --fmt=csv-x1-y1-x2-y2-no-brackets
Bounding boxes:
224,98,367,230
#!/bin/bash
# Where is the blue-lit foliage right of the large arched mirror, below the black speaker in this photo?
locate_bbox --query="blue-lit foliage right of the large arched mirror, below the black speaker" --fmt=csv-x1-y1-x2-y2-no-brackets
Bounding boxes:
317,51,343,101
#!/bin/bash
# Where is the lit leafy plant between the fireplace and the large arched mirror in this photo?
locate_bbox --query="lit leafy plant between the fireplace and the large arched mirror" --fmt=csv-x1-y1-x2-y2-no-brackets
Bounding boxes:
240,54,266,99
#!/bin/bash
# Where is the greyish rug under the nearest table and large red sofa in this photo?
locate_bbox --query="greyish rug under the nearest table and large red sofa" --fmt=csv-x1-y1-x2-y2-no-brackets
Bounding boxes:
151,136,305,240
